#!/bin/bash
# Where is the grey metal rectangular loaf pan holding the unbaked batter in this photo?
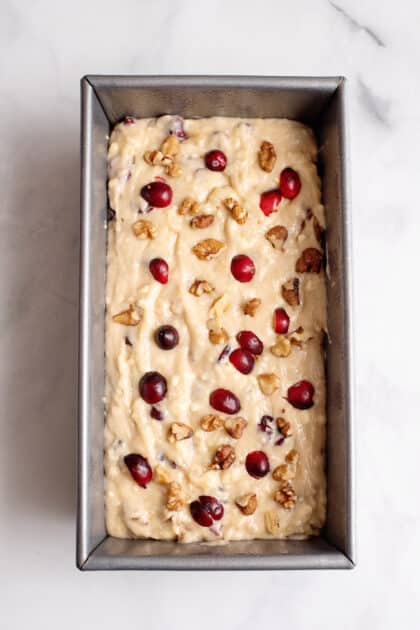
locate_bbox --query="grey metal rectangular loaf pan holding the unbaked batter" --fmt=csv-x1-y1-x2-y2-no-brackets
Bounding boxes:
77,76,355,570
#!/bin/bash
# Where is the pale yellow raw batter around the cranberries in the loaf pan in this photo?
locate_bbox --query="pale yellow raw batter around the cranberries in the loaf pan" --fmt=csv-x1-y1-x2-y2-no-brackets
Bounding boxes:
105,116,326,542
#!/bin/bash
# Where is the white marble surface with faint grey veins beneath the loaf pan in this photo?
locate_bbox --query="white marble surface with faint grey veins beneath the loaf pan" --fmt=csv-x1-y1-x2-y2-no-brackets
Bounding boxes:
0,0,420,630
